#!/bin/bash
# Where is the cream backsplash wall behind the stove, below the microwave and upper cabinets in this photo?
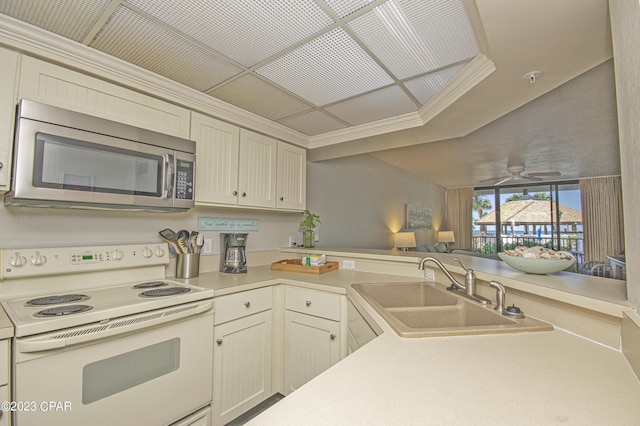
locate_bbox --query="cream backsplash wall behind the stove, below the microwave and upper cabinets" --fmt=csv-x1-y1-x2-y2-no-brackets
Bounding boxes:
0,205,300,254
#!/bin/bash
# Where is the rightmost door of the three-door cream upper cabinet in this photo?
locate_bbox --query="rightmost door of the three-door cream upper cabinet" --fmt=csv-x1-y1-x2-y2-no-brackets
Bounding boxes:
276,141,307,210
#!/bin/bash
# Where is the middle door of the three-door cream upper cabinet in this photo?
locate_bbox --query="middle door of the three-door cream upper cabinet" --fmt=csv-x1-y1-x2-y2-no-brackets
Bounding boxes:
238,129,278,208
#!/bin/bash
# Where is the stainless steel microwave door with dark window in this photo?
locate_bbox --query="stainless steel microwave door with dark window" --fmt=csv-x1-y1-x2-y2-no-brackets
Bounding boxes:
14,119,173,207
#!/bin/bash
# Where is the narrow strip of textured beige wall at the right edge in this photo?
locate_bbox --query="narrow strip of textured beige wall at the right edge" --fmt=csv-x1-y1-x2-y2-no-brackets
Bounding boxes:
609,0,640,310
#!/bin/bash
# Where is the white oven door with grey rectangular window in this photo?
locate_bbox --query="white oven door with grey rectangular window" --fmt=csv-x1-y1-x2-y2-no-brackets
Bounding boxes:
13,304,213,426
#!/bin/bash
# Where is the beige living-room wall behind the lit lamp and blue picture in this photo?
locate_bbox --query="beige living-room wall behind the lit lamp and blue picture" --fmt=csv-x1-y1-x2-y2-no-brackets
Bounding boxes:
307,154,444,249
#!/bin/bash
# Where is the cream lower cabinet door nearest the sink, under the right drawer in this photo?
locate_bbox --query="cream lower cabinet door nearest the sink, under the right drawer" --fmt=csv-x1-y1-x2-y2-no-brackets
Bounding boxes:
284,311,341,395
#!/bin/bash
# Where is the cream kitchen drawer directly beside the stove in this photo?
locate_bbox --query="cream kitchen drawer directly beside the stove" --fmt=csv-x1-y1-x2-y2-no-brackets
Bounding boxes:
213,287,273,324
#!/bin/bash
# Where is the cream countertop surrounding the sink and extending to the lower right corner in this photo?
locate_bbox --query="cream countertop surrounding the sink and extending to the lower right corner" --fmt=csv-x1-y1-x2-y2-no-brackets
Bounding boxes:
179,266,640,425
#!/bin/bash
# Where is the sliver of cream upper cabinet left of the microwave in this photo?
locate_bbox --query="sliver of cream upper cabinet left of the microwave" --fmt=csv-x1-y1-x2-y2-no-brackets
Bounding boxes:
0,48,18,193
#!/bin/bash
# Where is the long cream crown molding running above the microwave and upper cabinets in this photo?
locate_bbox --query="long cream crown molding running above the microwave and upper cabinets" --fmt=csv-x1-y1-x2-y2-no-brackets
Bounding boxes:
0,15,309,148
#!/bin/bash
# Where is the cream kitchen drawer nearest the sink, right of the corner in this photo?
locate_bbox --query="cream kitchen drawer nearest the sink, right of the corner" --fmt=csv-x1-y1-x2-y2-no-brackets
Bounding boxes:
285,287,342,321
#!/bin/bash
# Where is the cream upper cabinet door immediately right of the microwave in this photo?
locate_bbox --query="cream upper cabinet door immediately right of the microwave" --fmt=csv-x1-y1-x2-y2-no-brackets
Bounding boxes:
191,112,240,205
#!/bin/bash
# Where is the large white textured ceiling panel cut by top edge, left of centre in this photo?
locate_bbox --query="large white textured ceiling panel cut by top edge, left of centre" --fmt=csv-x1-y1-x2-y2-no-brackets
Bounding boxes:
129,0,334,67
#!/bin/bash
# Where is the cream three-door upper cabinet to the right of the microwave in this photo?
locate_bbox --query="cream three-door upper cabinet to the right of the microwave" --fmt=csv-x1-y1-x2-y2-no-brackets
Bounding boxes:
191,112,306,210
